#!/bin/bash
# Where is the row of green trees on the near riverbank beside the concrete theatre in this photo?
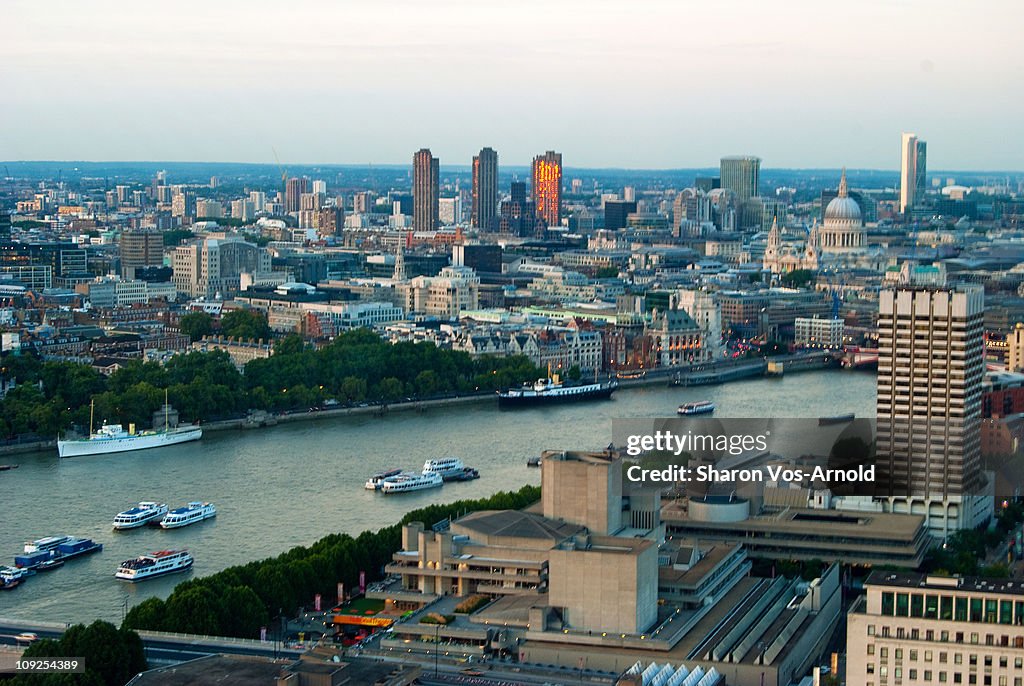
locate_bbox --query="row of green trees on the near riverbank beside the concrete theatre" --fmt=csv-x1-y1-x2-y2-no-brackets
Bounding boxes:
124,486,541,638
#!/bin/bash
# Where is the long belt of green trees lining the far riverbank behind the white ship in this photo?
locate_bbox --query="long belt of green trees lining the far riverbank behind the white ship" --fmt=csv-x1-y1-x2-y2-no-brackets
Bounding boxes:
0,329,541,437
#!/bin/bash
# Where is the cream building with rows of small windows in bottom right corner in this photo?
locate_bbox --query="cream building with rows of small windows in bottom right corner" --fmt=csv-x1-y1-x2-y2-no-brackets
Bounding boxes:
846,571,1024,686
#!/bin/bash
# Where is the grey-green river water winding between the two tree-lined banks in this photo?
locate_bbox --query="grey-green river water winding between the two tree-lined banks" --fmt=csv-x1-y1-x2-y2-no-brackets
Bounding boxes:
0,371,874,623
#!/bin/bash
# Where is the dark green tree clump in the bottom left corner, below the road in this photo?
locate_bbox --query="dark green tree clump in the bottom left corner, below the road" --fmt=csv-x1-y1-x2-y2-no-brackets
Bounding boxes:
7,619,147,686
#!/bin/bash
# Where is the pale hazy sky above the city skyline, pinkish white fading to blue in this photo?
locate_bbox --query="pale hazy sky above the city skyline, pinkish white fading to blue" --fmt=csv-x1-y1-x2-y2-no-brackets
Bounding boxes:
0,0,1024,170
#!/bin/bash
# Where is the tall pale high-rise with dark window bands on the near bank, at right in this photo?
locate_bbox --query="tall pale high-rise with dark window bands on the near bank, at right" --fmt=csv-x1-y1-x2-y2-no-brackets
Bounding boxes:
876,285,992,538
